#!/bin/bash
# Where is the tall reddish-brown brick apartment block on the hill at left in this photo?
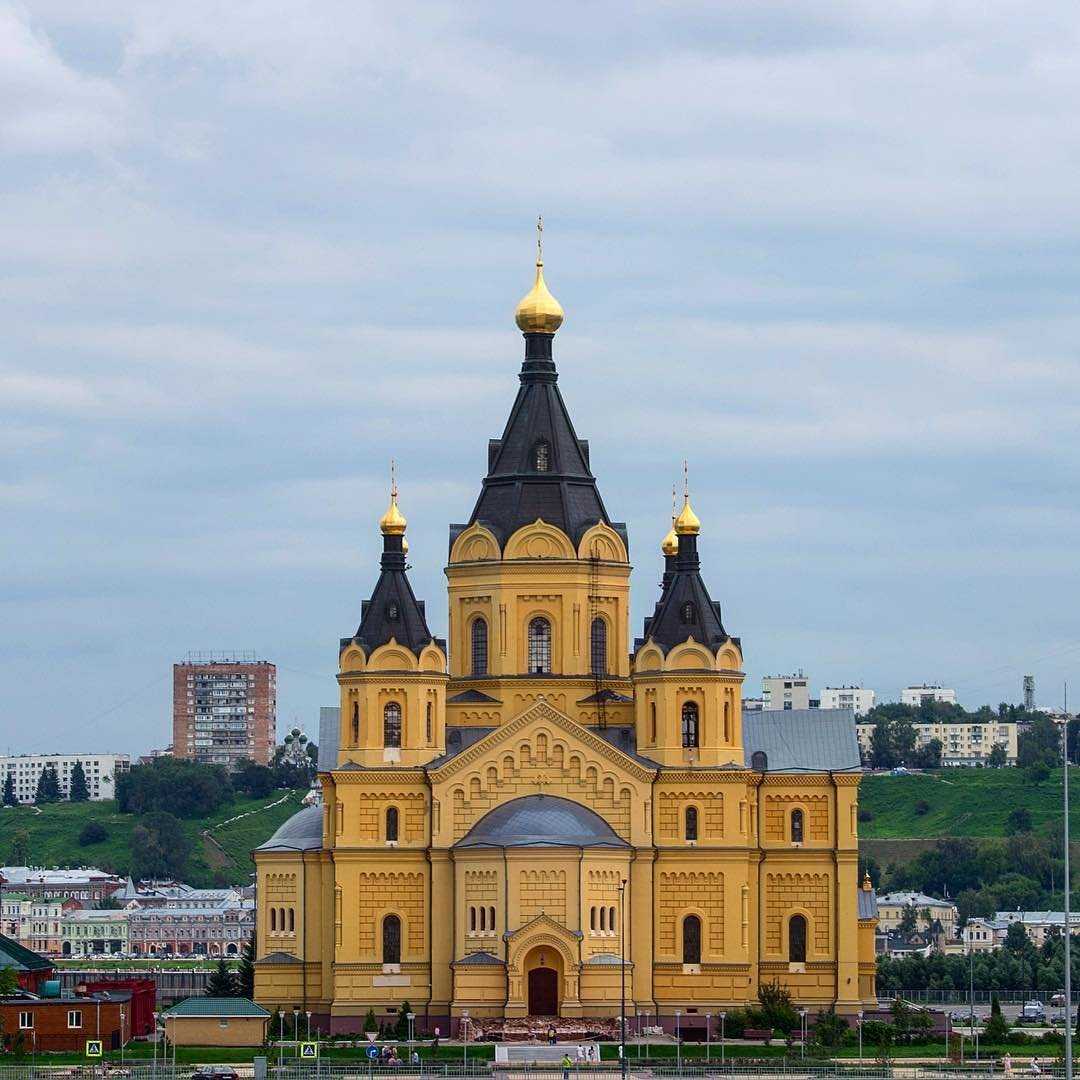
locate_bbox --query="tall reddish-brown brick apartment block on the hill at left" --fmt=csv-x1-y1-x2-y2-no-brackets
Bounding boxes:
173,653,278,766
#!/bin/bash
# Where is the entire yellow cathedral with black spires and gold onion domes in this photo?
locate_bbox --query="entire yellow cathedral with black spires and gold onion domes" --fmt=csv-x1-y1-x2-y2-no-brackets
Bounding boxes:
254,240,876,1034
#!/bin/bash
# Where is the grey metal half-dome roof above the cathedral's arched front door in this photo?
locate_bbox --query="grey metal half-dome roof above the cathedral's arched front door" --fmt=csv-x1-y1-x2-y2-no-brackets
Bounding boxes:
455,795,627,848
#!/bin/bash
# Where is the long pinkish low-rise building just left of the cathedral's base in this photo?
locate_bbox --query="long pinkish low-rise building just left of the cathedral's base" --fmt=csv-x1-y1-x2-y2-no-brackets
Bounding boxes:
126,901,255,956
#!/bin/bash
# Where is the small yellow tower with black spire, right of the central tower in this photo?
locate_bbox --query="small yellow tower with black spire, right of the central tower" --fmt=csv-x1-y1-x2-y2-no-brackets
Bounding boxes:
633,475,745,767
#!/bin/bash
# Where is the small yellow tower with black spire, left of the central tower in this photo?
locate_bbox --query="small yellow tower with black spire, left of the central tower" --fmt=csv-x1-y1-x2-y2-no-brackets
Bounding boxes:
338,481,447,767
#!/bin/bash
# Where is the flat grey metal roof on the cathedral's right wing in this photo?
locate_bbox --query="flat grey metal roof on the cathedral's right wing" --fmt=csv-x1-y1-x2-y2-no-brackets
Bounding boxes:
743,708,862,772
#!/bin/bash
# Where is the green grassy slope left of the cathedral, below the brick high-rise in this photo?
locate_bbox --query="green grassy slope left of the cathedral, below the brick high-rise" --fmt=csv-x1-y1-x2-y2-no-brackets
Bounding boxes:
0,792,302,887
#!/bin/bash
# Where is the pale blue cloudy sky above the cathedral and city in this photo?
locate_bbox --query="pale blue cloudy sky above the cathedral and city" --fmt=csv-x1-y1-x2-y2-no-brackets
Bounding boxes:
0,0,1080,752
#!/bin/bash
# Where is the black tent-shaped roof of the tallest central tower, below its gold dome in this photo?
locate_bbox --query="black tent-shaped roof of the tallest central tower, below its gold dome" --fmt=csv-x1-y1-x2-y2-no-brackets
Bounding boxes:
450,334,629,548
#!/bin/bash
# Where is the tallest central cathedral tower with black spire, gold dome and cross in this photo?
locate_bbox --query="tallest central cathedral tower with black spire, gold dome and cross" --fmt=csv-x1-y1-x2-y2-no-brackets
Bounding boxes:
446,224,633,727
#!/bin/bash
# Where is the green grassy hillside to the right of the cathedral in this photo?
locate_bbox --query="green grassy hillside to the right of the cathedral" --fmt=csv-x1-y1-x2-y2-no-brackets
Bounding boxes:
859,768,1080,840
